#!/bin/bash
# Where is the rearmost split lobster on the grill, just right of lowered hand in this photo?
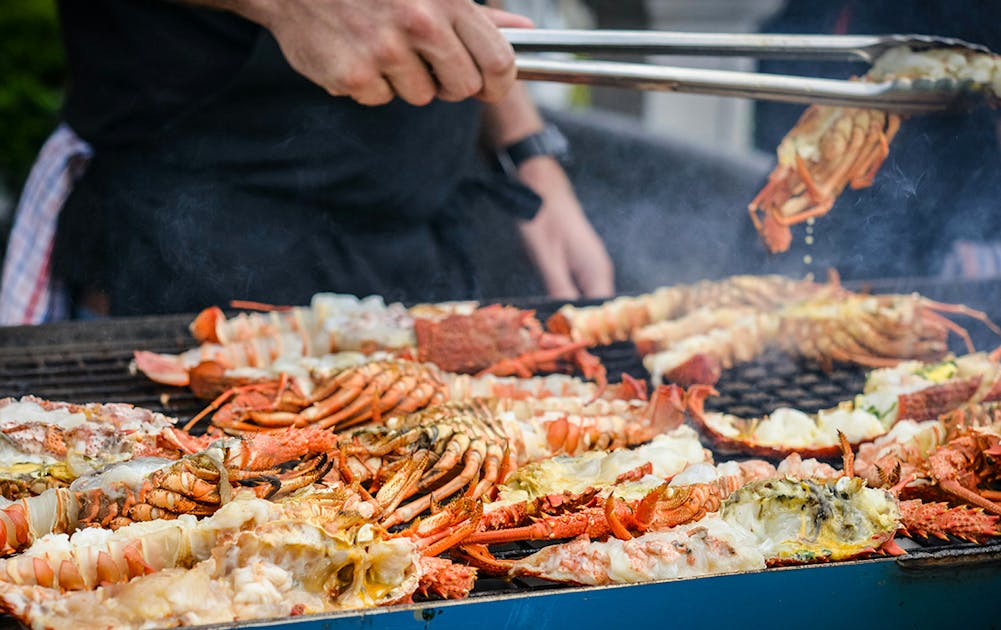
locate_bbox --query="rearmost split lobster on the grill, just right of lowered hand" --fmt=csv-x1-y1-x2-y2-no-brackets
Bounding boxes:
546,275,847,346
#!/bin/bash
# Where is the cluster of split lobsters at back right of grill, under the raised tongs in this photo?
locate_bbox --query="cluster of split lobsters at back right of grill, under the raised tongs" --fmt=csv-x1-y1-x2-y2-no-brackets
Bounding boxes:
548,273,1001,386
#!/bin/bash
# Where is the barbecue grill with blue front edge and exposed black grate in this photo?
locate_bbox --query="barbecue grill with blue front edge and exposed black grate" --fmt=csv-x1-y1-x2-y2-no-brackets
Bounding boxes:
0,279,1001,628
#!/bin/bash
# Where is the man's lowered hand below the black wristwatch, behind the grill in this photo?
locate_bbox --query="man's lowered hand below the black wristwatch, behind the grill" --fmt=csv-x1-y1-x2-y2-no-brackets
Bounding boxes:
518,156,615,299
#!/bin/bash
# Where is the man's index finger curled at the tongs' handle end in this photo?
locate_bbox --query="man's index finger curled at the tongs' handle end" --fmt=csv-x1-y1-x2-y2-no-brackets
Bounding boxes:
454,11,518,103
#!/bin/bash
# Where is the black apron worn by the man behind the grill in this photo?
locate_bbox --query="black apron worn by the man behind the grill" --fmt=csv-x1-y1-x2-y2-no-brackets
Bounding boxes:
54,1,539,314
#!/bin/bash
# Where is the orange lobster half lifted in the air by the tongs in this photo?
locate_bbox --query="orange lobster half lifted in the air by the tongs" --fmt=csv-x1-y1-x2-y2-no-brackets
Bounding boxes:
748,47,1001,253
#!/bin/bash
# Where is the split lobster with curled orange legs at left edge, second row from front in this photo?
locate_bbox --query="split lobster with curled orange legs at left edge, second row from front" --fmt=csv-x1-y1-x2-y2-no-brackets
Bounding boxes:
0,429,336,555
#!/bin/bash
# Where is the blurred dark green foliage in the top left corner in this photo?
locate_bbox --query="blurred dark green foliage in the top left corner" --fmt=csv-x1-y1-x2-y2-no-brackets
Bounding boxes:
0,0,65,195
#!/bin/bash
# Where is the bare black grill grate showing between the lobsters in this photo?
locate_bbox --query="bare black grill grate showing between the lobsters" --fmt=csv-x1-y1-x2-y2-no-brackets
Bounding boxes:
0,280,1001,628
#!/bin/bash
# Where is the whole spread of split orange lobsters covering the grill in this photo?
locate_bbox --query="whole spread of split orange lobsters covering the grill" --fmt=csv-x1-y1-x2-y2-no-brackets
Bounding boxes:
0,276,1001,628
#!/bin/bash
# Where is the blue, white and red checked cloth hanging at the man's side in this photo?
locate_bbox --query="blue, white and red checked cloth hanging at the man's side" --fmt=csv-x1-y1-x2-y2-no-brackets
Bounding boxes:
0,124,92,326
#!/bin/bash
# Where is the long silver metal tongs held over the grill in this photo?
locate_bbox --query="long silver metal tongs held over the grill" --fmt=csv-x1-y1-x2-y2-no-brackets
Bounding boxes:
503,29,990,114
